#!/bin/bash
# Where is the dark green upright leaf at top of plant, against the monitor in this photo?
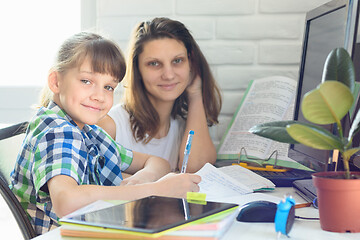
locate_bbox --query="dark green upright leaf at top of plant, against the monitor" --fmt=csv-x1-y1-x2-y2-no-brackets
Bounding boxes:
322,48,355,92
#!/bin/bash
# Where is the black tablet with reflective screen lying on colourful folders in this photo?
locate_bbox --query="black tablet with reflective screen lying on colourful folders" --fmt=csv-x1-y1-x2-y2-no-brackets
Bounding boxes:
60,196,238,234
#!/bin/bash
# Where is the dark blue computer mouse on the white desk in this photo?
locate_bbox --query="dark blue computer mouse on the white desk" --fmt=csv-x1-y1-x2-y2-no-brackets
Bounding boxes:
236,201,277,222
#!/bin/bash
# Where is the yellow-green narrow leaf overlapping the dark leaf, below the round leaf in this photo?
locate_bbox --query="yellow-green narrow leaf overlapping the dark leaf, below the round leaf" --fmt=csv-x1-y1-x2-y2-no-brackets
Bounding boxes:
286,123,344,150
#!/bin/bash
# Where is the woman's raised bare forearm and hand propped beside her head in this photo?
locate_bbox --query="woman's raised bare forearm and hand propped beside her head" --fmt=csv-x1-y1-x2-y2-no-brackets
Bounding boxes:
179,76,216,172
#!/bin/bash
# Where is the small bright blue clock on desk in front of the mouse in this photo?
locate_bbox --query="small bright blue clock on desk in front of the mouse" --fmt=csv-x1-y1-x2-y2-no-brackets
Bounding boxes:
275,196,295,236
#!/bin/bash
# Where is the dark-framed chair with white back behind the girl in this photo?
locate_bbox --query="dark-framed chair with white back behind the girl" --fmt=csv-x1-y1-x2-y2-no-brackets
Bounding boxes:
0,122,36,239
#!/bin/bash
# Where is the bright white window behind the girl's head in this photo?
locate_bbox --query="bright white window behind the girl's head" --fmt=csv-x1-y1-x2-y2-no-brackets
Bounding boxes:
0,0,81,87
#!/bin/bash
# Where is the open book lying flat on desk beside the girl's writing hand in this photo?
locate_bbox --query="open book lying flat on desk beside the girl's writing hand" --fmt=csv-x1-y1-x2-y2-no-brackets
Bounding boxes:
196,163,275,201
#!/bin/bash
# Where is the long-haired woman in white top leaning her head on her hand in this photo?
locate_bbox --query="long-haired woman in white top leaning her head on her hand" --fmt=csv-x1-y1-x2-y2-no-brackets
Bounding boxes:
98,18,221,172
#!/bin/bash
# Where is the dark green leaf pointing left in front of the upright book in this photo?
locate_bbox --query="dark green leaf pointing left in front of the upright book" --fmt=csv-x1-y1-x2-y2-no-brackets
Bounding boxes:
249,121,298,144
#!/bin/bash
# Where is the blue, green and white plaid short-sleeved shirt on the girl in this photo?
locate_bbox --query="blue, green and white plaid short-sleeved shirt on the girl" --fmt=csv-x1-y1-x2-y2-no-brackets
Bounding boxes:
11,102,133,234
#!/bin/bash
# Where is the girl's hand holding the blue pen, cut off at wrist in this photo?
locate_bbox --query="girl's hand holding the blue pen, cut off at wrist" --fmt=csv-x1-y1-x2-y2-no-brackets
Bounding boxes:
156,173,201,198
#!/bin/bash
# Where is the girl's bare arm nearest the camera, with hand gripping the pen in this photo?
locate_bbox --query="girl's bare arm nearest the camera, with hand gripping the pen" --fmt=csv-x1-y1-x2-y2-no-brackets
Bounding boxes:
47,173,201,217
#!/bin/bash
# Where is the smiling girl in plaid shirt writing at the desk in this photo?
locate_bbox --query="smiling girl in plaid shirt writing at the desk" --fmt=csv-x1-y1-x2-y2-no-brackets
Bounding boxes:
11,33,200,234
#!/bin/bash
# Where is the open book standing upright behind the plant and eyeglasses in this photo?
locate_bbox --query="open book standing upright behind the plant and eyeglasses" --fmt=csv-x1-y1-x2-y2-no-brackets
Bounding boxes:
217,76,309,170
